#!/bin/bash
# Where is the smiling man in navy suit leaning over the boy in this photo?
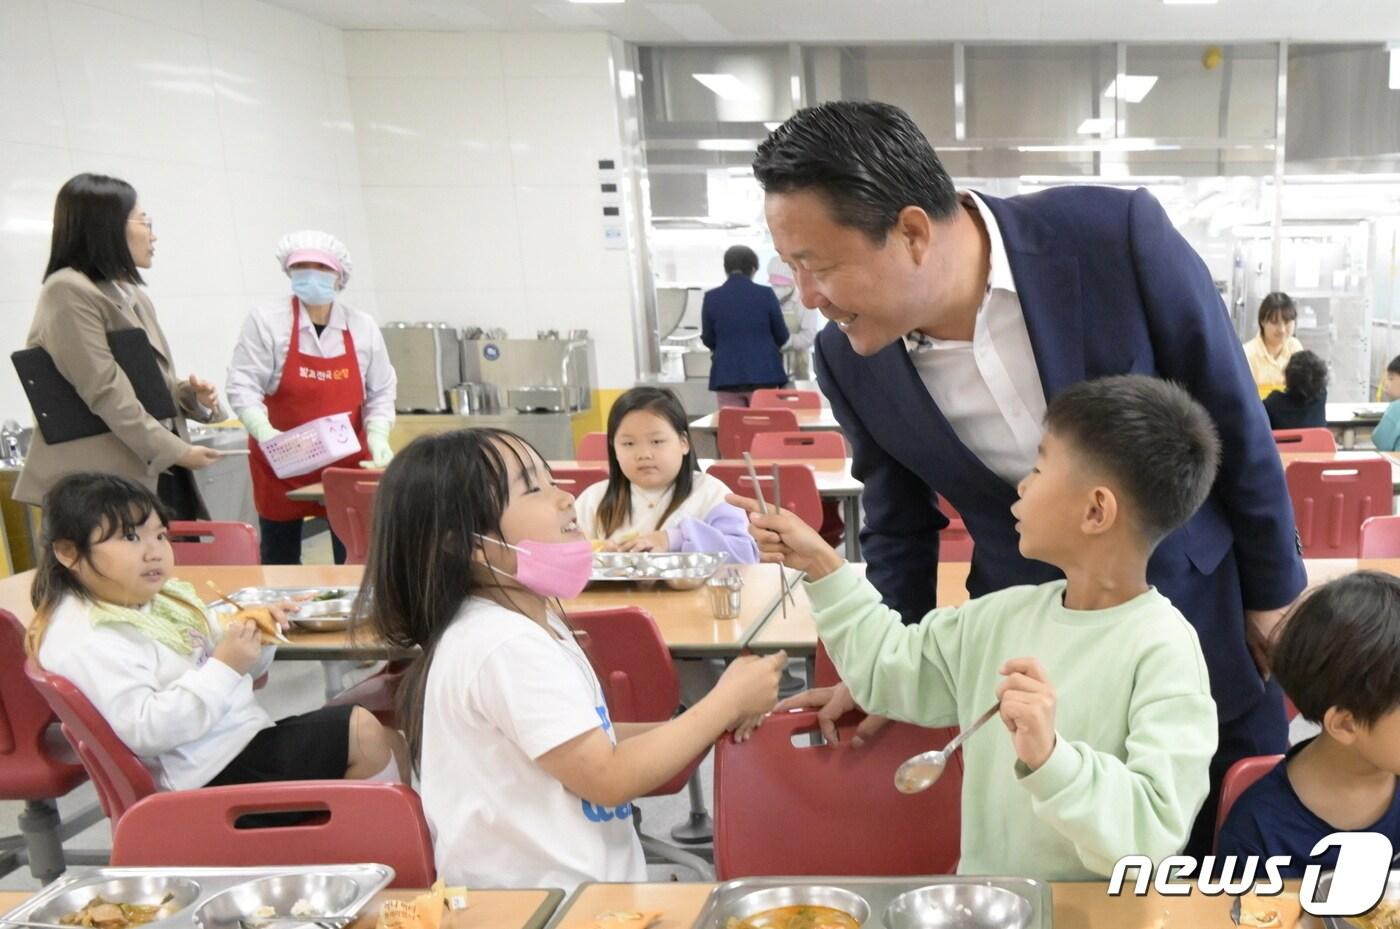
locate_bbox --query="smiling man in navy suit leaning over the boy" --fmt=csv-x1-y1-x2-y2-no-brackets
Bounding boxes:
753,102,1306,853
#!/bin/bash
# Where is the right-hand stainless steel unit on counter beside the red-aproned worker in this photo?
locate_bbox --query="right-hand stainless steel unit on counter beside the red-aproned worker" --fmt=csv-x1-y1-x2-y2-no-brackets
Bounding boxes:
462,339,598,413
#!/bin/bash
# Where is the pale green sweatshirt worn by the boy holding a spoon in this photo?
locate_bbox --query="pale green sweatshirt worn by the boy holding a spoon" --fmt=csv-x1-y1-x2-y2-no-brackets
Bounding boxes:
806,565,1217,880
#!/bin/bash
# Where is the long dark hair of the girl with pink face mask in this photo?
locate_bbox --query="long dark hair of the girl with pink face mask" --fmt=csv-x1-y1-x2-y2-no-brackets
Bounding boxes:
354,428,554,770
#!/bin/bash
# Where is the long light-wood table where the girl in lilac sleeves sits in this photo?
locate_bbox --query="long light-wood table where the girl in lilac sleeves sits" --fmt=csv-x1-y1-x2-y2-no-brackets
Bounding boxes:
0,565,781,660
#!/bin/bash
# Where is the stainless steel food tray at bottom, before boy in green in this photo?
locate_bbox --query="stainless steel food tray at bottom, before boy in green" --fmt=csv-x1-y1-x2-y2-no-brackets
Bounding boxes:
692,874,1051,929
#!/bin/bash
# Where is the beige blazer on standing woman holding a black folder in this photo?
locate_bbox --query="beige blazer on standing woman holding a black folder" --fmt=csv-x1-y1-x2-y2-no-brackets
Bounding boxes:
14,269,224,505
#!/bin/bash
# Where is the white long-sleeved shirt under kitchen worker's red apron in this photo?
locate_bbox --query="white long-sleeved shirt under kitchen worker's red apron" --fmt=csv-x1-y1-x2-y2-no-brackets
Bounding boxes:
224,298,399,423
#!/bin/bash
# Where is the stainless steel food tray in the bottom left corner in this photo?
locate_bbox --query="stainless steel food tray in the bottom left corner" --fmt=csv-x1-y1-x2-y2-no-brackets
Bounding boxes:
4,863,393,929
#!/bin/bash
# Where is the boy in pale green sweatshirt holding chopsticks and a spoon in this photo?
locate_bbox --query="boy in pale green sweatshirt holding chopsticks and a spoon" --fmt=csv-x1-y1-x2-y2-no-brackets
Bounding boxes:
731,375,1219,880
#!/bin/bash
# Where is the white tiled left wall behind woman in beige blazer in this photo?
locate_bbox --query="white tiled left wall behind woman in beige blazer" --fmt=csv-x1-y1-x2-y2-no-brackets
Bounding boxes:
0,0,375,423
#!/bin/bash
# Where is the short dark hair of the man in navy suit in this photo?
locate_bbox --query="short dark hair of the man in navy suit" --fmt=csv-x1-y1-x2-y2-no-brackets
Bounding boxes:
753,101,958,245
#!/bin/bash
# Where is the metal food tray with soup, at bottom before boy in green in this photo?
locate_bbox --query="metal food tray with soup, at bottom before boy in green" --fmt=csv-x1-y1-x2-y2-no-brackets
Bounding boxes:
692,874,1053,929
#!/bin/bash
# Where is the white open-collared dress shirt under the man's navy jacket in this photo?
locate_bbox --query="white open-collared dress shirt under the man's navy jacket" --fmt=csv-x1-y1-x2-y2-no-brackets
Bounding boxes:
904,192,1046,484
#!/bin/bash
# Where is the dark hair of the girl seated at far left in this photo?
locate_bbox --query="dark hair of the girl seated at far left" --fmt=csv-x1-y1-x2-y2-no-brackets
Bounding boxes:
24,473,169,659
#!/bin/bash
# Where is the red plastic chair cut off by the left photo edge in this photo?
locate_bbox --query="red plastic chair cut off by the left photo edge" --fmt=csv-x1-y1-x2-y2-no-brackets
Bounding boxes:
0,610,106,883
